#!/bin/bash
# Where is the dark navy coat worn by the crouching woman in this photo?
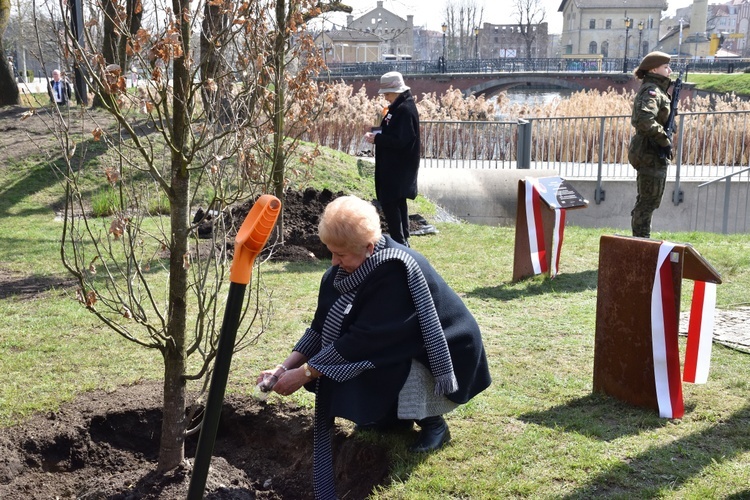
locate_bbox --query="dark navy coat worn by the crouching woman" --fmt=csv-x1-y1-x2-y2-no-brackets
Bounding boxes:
300,237,491,424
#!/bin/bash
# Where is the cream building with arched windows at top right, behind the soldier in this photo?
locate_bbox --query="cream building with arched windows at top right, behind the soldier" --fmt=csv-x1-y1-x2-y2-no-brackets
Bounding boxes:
558,0,667,58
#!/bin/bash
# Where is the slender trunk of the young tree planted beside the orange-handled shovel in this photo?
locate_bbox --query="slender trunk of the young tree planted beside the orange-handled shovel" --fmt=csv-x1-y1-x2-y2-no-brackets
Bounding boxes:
157,0,192,472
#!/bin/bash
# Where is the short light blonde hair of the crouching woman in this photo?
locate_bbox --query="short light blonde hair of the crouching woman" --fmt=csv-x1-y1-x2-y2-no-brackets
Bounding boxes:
318,196,381,251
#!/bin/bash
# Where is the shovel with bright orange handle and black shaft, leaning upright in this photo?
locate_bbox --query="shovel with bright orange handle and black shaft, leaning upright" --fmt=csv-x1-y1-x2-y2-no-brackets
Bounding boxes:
187,194,281,500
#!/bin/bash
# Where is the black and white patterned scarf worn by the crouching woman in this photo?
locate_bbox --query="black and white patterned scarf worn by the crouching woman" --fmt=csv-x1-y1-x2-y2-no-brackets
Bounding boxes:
312,237,458,500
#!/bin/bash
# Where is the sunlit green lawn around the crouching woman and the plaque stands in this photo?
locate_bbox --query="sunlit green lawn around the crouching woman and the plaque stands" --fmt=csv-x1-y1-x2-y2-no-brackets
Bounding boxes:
0,144,750,500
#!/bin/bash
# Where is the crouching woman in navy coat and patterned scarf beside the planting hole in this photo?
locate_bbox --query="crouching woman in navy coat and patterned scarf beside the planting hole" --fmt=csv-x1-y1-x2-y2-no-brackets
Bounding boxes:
257,196,491,500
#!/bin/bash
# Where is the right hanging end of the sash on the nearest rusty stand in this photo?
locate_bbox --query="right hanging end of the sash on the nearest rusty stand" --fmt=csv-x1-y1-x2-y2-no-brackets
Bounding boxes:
682,281,716,384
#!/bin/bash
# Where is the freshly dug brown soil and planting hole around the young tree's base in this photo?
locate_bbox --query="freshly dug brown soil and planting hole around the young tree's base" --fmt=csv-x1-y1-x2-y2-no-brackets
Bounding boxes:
0,382,388,500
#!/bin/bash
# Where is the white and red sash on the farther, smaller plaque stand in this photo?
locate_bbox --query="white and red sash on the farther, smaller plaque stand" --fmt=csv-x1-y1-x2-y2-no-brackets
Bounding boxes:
525,177,565,278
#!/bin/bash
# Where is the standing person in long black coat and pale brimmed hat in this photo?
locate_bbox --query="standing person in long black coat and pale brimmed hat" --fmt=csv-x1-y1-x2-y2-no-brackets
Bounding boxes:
365,71,420,246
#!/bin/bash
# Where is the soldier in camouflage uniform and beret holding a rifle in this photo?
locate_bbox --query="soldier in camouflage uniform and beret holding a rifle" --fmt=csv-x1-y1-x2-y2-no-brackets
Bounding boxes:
628,52,672,238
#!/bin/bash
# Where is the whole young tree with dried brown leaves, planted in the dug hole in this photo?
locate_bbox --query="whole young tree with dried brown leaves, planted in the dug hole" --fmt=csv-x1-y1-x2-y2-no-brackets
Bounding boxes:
31,0,340,472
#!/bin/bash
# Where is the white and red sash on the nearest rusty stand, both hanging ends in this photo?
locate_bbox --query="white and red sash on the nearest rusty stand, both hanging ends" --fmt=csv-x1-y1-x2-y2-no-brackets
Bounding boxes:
651,241,716,418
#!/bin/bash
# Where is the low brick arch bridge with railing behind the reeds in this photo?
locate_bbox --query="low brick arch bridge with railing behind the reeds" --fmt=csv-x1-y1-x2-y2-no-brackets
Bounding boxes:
338,71,641,98
